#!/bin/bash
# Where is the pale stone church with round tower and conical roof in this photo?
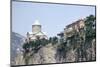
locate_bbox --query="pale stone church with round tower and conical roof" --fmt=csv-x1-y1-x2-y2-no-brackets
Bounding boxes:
27,20,48,41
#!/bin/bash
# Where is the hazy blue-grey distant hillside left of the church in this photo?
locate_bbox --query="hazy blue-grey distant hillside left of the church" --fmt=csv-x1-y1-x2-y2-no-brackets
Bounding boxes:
11,32,25,64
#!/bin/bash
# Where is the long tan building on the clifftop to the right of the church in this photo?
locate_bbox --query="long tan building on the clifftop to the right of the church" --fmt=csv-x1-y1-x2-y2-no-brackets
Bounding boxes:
58,19,85,40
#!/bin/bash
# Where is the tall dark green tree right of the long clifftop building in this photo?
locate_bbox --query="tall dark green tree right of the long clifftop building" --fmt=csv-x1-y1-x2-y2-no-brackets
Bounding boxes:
85,15,96,40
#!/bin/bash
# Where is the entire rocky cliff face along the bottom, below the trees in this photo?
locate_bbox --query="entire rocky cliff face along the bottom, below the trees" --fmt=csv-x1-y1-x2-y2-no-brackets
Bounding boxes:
16,39,96,65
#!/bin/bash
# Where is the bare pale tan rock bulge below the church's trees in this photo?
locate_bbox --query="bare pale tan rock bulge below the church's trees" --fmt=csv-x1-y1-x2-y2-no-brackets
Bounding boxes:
29,44,56,64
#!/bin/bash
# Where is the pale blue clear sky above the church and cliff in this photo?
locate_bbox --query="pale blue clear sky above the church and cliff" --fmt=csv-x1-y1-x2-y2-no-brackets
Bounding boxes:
12,1,95,37
